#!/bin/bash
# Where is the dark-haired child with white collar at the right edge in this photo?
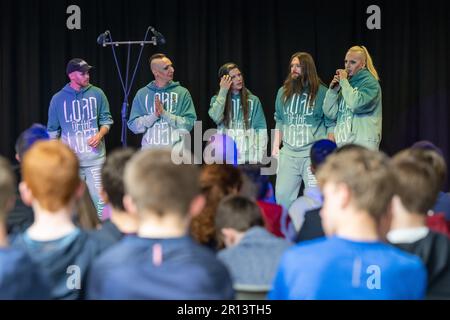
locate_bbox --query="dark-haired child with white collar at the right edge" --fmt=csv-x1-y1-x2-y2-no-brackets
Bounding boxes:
387,149,450,299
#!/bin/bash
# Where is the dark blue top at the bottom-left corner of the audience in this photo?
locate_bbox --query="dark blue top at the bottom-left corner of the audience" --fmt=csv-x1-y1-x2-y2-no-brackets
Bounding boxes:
0,248,50,300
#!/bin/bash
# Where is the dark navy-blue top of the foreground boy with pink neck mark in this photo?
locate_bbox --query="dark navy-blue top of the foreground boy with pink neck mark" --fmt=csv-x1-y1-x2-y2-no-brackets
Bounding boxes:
88,236,234,300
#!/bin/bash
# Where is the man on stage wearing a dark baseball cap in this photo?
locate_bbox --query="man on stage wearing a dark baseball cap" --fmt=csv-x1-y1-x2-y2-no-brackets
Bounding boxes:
47,58,113,216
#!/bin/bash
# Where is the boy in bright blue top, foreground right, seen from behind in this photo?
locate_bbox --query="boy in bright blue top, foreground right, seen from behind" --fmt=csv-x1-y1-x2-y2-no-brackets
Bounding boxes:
269,148,426,299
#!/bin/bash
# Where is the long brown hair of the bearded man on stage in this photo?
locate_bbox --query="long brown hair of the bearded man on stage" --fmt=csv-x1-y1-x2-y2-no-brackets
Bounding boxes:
283,52,322,106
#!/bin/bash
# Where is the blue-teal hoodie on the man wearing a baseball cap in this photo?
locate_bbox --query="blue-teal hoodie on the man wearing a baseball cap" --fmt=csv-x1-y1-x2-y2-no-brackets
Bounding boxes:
47,84,113,167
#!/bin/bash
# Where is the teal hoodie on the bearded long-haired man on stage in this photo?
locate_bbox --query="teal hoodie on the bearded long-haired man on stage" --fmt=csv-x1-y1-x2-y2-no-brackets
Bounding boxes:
275,85,334,158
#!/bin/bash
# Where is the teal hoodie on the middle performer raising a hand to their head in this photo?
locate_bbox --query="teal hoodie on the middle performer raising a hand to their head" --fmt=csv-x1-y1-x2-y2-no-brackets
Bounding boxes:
208,89,267,164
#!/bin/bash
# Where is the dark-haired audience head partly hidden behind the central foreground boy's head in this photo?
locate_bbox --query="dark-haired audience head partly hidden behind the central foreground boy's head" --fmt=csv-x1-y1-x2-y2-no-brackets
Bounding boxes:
102,148,135,211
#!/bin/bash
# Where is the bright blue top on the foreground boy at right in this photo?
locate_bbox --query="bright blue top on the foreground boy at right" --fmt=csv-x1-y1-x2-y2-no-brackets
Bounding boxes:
269,237,426,300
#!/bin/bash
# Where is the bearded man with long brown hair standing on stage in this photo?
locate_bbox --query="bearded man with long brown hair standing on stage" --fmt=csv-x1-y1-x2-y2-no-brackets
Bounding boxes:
272,52,334,209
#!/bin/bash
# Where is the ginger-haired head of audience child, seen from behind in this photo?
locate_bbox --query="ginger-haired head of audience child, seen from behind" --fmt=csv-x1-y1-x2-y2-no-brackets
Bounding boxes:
20,140,83,212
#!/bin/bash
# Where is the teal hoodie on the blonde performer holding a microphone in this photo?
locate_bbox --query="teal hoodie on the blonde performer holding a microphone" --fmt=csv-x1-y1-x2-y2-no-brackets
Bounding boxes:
323,69,382,150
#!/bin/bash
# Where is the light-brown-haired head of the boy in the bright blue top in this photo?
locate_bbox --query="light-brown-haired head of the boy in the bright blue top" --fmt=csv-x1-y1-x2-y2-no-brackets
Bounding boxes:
317,147,396,234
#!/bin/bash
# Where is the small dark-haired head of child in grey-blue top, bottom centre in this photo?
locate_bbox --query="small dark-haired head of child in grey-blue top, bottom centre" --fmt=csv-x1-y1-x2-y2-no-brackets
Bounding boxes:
215,195,264,246
